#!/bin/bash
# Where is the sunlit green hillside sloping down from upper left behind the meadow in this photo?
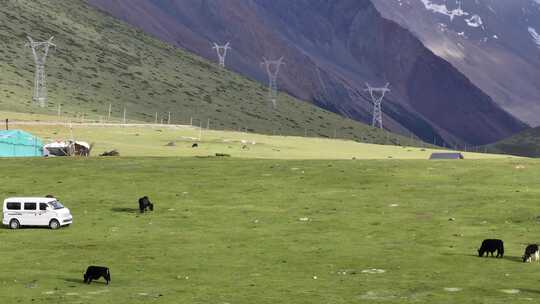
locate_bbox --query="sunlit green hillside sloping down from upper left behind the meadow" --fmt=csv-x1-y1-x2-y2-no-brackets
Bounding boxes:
0,0,417,145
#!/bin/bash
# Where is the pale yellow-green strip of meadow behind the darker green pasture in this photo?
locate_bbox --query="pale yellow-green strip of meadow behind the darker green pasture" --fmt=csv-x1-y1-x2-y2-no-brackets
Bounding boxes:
12,124,511,159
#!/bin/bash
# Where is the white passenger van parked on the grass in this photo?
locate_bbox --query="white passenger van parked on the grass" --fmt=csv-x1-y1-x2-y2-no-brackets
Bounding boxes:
2,197,73,229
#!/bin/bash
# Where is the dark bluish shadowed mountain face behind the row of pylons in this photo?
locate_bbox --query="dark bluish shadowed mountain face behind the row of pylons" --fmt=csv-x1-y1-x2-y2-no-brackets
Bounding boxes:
89,0,526,144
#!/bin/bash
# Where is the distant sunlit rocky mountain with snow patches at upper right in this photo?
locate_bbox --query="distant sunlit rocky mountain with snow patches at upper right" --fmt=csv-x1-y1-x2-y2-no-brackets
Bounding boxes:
373,0,540,126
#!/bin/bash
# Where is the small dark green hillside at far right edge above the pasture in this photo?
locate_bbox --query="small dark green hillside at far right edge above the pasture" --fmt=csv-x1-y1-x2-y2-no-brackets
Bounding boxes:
487,128,540,157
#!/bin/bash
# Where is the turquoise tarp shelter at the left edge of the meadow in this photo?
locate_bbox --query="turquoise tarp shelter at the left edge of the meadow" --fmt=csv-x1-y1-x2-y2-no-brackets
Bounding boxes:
0,130,43,157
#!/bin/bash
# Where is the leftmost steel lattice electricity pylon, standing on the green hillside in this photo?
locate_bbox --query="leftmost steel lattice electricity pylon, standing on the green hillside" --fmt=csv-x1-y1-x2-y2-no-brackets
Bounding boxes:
25,36,56,107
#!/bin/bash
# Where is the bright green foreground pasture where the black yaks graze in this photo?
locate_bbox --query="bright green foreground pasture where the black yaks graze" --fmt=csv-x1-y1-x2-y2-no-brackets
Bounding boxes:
0,158,540,304
